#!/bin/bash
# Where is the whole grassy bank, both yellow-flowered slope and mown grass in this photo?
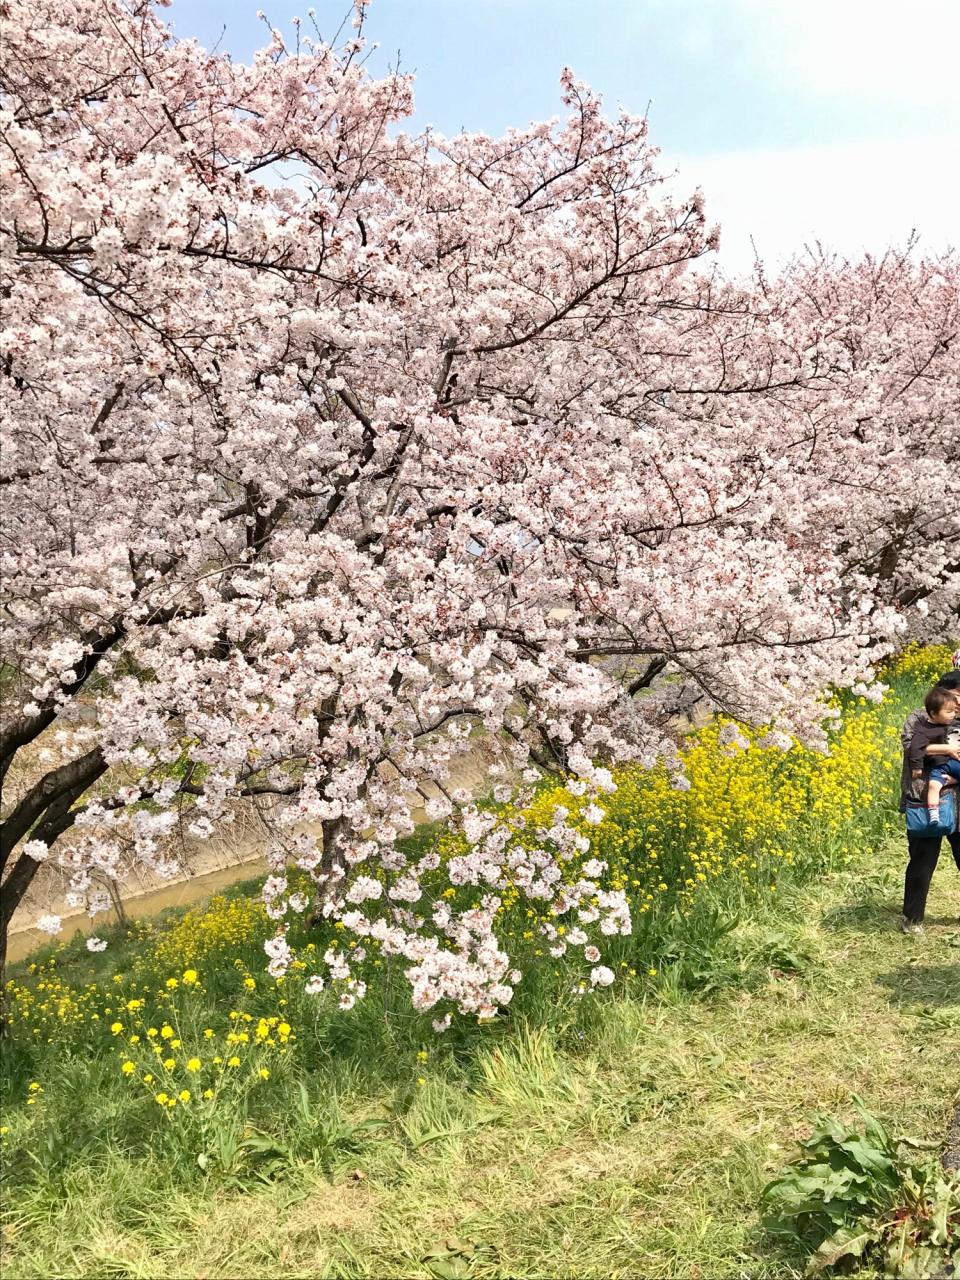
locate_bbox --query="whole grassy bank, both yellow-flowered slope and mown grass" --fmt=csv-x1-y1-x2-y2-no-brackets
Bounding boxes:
0,650,960,1280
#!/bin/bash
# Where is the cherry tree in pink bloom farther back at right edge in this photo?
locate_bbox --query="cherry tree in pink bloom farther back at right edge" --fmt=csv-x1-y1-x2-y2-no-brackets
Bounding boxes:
760,242,960,639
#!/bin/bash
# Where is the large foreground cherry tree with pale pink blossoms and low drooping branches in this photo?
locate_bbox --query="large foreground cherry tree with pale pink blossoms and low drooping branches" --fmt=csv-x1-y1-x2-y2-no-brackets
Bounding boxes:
0,0,956,1003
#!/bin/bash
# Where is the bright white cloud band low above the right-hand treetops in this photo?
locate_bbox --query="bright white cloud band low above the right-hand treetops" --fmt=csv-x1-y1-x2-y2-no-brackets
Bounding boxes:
662,134,960,271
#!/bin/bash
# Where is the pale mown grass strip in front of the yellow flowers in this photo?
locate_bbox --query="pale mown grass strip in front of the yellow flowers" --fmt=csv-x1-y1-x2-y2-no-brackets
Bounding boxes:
4,842,960,1280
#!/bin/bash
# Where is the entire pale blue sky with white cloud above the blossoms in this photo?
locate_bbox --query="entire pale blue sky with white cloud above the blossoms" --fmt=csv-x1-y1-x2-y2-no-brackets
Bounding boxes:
166,0,960,270
